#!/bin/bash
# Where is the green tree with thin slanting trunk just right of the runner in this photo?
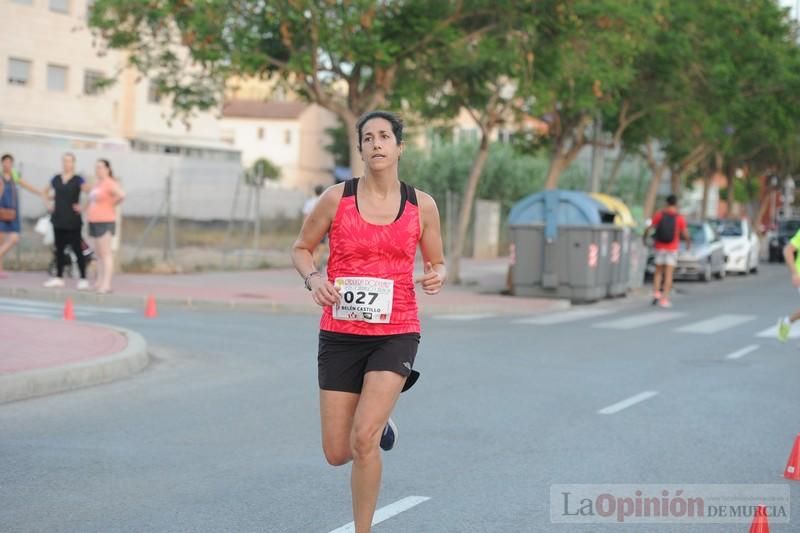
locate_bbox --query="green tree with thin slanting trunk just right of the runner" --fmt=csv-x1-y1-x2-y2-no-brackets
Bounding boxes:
394,0,538,283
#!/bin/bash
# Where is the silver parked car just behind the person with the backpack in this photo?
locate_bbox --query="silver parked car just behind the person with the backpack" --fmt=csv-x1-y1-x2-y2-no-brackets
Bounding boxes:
647,221,726,281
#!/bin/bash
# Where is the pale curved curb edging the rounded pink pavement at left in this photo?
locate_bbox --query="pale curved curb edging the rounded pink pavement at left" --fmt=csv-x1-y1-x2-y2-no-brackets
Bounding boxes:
0,324,149,404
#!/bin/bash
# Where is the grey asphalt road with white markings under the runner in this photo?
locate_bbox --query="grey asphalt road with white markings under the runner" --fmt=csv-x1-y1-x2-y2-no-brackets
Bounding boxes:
0,265,800,533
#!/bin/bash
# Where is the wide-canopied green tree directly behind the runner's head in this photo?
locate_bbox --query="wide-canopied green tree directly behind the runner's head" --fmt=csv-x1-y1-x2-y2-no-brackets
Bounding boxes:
90,0,487,173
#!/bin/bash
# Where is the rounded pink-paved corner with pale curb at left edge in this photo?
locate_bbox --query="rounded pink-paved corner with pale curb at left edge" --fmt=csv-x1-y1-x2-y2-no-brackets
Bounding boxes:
0,315,148,403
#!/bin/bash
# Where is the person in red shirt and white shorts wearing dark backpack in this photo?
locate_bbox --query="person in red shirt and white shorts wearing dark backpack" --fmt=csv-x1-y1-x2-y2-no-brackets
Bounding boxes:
645,194,692,308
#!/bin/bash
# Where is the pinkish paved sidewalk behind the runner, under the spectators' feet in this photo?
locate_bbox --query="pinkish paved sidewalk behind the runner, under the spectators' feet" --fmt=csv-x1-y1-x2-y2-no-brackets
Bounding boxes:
0,259,569,314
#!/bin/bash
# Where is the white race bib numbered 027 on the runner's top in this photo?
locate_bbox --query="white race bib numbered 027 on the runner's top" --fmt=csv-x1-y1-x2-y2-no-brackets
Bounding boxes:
332,278,394,324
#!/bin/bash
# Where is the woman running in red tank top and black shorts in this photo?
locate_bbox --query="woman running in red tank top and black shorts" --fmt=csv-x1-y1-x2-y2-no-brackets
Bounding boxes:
292,111,447,533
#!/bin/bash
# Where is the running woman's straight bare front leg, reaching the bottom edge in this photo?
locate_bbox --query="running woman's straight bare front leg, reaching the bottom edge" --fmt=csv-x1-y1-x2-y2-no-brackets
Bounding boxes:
350,370,406,533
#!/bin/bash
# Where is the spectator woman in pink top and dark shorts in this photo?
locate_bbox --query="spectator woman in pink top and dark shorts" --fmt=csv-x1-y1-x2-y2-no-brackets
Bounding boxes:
87,159,125,294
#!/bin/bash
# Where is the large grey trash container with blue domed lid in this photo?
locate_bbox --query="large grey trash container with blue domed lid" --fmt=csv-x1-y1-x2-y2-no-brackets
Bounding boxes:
508,190,621,303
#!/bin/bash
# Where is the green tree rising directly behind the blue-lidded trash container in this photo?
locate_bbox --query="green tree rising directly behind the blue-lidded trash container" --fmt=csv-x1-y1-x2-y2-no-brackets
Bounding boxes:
534,0,663,189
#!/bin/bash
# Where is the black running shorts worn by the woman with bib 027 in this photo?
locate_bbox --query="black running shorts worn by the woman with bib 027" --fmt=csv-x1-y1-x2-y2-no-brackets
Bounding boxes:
317,330,419,393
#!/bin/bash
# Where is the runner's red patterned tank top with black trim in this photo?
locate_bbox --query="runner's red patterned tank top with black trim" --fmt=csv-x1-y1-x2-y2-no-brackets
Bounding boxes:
320,178,420,335
